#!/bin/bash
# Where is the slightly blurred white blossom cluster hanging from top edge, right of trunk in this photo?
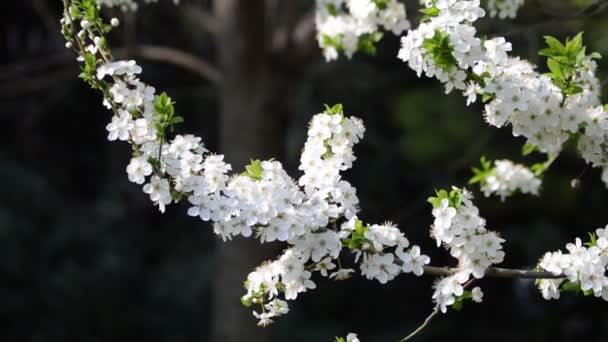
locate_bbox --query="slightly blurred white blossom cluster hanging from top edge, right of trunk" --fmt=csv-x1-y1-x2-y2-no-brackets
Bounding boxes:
315,0,410,61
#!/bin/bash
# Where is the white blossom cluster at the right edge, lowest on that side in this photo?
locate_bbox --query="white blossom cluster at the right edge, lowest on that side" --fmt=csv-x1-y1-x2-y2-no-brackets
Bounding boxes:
537,227,608,301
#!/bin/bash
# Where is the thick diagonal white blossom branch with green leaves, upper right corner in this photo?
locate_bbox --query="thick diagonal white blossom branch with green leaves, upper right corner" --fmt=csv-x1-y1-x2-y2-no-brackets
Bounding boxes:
398,0,608,187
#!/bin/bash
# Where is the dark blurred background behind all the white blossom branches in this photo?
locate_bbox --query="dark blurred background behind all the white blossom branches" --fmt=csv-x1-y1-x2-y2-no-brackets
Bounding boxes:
0,0,608,342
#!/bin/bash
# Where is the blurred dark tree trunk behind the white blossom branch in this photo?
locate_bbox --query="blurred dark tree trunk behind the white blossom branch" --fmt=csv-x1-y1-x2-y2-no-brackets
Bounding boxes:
212,0,287,342
